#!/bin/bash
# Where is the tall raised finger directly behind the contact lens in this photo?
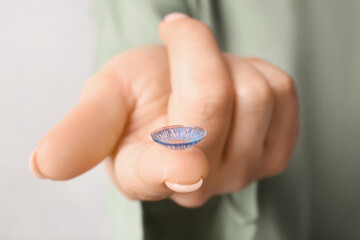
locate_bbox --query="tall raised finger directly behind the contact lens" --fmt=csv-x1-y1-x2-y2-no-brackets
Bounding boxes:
159,13,232,159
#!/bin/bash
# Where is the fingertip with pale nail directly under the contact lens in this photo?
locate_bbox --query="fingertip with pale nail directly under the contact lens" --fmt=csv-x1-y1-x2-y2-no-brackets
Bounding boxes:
139,145,210,192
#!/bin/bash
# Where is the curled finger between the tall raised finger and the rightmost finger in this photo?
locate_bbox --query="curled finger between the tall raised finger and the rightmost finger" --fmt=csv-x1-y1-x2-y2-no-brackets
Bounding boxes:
221,54,274,187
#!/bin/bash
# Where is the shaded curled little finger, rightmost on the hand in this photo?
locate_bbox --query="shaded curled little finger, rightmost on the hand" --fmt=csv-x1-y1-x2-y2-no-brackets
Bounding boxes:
247,58,299,176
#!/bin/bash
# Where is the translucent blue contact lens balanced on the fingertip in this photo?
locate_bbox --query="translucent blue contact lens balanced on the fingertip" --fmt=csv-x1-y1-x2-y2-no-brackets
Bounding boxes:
150,125,206,150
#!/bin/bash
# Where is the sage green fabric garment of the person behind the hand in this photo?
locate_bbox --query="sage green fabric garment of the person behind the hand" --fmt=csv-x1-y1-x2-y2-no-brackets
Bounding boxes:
94,0,360,240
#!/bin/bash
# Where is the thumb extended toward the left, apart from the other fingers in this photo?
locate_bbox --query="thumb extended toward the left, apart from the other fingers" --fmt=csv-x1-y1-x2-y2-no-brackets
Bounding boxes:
30,56,131,180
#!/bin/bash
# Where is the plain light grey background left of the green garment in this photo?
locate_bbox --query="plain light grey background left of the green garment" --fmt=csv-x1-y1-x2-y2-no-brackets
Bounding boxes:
0,0,114,239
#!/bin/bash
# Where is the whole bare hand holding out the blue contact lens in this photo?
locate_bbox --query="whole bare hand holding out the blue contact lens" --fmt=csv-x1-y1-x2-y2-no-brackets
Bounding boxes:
30,13,299,207
